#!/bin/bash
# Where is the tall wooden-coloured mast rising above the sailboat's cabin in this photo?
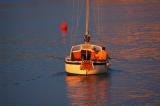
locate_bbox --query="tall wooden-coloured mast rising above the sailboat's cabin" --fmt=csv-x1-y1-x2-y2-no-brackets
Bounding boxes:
84,0,90,43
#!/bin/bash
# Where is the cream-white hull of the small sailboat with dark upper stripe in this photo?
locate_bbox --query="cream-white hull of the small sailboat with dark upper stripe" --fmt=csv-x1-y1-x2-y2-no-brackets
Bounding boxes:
65,61,109,75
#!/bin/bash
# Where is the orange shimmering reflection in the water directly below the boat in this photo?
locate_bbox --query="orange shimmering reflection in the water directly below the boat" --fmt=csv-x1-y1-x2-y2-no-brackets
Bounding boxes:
65,74,109,106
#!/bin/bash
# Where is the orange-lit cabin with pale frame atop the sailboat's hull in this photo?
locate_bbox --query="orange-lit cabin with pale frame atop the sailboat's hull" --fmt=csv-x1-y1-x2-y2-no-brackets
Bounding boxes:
70,44,102,61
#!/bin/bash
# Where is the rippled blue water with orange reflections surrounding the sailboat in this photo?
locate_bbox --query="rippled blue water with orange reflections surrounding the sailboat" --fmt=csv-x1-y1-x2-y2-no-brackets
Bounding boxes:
0,0,160,106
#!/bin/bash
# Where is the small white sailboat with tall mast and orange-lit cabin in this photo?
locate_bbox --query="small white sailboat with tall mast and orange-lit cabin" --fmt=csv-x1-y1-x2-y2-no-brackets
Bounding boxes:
65,0,110,75
